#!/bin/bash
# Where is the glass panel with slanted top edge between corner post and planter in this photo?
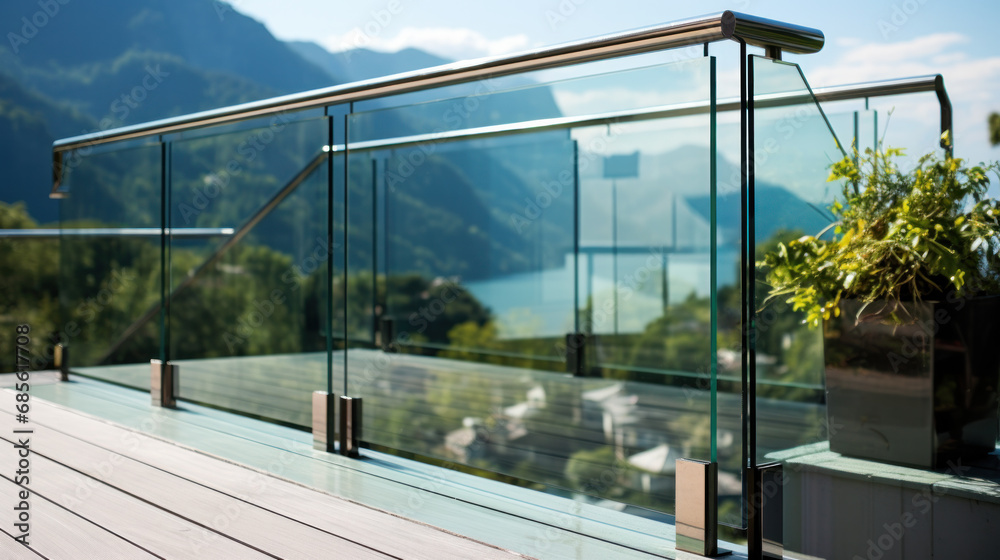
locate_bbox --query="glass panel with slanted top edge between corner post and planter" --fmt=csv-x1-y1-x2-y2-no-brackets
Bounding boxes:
750,57,848,557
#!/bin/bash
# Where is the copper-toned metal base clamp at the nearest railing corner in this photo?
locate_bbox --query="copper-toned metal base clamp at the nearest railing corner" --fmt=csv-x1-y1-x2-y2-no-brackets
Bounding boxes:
675,459,719,556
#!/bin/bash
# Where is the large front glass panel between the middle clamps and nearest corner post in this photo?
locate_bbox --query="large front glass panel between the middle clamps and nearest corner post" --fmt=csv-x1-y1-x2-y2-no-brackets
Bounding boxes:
347,54,720,528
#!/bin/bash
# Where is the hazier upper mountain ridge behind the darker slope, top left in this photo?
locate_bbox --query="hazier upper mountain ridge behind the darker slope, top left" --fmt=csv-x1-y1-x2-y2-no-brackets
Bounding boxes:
0,0,342,94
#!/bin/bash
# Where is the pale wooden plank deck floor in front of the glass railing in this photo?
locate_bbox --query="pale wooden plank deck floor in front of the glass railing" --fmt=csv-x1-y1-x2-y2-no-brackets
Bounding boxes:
0,374,688,560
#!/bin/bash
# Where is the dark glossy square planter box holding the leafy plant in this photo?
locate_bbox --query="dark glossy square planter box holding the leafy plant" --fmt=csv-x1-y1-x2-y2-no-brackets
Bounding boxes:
823,297,1000,468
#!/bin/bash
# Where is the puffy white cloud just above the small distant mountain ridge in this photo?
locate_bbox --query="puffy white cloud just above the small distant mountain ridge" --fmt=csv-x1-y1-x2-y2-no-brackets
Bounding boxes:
323,27,530,60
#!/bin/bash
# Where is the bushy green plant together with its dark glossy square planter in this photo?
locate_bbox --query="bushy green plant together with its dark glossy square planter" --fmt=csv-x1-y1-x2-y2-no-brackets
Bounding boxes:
757,141,1000,467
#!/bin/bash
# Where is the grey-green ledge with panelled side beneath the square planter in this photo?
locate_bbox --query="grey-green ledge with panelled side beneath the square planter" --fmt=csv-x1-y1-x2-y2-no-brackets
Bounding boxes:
768,442,1000,560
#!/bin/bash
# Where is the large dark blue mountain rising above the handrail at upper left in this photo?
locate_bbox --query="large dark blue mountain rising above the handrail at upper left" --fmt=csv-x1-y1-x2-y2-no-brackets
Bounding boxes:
0,0,342,223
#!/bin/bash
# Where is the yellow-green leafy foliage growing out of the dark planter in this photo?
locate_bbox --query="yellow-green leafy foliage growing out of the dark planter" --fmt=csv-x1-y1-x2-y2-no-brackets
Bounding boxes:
757,148,1000,327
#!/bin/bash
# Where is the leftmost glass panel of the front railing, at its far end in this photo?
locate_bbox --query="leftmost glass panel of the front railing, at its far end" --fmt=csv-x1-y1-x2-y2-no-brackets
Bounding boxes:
59,144,162,390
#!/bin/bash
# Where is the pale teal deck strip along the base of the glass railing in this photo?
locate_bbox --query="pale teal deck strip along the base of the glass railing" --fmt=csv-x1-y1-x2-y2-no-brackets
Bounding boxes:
21,380,673,560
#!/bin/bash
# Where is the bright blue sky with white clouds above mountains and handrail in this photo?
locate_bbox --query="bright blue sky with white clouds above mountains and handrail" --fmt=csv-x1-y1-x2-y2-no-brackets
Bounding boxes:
231,0,1000,171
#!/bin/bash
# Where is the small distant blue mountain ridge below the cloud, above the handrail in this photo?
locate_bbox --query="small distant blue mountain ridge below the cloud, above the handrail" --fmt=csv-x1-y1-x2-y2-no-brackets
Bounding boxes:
288,41,451,82
